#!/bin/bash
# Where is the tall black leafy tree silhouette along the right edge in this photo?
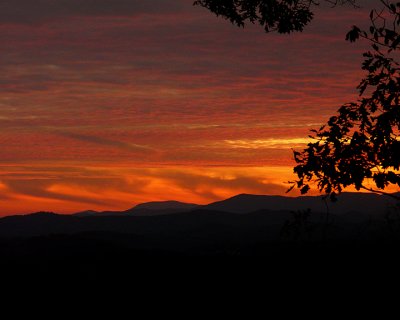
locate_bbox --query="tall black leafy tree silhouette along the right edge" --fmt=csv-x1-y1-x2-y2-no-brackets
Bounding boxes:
292,0,400,199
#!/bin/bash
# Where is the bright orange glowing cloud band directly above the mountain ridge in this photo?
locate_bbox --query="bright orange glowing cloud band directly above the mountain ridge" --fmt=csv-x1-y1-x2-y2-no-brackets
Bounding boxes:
0,165,304,215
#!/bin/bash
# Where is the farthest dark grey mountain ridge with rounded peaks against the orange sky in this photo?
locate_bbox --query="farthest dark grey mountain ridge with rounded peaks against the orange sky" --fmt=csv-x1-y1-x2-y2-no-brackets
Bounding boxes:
75,193,396,217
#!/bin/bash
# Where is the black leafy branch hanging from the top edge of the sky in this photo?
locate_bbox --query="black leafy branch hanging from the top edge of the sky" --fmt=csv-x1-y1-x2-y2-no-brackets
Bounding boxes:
194,0,356,33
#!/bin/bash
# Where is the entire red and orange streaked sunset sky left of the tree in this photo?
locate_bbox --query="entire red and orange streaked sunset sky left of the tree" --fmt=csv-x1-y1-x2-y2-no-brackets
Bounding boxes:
0,0,376,215
